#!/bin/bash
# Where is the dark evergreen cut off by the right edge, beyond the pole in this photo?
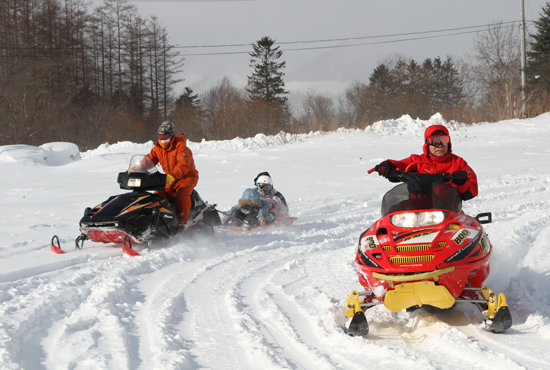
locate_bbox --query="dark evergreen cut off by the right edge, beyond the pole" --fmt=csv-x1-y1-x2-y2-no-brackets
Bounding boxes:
526,4,550,95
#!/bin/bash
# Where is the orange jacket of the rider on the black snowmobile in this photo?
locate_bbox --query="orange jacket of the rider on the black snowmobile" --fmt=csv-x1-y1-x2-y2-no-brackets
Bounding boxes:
147,134,199,184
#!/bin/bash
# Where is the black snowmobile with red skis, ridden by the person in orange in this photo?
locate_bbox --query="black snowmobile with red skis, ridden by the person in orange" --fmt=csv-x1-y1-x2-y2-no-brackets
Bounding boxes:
52,155,221,255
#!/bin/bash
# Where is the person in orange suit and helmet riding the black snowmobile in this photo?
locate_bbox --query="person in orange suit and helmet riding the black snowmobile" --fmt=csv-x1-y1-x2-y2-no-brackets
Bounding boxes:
147,121,199,226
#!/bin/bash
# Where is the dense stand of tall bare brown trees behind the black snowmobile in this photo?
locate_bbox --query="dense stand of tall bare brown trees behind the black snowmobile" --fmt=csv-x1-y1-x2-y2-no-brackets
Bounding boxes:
0,0,183,148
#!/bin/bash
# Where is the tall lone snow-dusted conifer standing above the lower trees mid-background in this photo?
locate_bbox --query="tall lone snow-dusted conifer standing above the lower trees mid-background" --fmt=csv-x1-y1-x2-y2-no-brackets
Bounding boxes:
246,36,289,105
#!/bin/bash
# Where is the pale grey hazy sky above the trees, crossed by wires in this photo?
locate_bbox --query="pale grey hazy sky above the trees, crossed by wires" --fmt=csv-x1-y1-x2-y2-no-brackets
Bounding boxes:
110,0,546,102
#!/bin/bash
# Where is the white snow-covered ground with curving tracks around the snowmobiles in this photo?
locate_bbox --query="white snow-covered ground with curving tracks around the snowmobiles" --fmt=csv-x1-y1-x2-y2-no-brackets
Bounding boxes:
0,114,550,370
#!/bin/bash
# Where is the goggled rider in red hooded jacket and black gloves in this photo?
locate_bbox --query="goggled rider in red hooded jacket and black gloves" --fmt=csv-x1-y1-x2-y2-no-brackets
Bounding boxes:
374,125,478,200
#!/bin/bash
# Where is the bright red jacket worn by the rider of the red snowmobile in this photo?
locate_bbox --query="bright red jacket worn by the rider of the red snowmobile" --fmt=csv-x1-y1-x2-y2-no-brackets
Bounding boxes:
389,134,477,200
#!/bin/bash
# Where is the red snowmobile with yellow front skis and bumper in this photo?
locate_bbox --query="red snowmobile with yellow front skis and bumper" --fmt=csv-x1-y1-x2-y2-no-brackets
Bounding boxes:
346,162,512,336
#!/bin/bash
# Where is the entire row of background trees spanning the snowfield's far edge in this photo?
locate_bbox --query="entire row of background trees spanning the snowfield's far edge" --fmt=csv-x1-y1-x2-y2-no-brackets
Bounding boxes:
0,0,550,149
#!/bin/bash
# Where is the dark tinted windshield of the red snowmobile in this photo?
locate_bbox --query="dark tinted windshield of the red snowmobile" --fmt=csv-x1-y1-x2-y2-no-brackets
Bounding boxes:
382,181,462,216
